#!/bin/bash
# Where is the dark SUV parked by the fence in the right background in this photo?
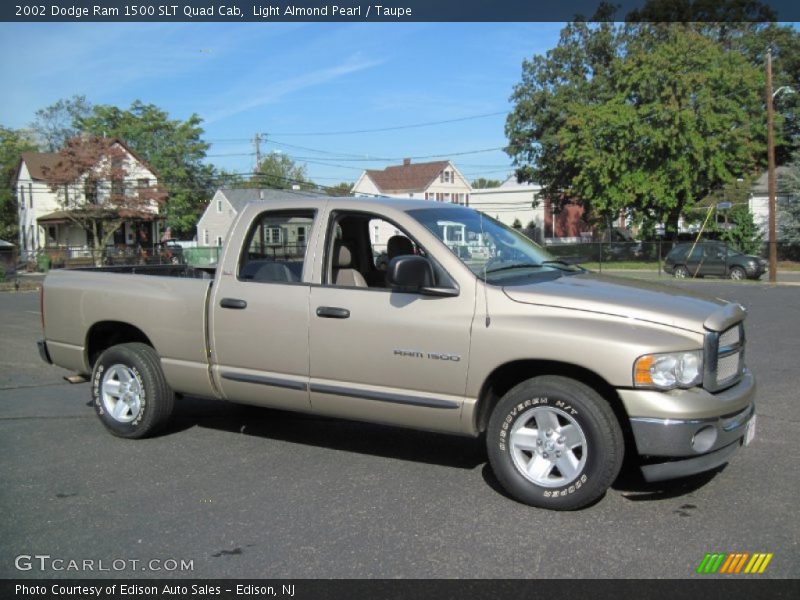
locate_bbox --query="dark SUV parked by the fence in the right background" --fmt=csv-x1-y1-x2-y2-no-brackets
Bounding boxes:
664,242,767,279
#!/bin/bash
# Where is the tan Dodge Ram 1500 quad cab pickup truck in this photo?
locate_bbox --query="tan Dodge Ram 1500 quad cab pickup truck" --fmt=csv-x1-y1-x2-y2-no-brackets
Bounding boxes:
39,196,755,509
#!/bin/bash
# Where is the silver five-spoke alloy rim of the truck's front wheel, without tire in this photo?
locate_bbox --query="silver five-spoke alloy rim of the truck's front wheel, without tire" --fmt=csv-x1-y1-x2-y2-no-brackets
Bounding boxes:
509,406,587,487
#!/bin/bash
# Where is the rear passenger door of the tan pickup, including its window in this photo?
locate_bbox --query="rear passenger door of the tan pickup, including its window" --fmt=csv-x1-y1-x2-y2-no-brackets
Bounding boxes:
210,209,315,410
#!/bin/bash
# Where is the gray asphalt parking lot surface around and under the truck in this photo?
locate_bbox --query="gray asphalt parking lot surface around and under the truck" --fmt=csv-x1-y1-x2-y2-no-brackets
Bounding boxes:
0,281,800,578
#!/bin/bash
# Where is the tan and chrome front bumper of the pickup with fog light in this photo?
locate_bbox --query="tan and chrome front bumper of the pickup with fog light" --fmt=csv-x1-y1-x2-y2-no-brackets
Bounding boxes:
621,371,755,481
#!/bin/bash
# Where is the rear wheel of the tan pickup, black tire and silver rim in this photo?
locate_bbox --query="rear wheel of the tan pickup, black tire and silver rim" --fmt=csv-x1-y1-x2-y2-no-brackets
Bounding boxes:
92,343,175,438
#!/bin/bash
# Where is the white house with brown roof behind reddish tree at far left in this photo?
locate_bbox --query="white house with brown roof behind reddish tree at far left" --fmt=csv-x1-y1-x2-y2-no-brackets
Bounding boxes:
14,138,158,259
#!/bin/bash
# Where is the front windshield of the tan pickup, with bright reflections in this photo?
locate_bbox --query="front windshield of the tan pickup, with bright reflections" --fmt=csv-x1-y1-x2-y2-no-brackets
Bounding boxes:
409,207,582,282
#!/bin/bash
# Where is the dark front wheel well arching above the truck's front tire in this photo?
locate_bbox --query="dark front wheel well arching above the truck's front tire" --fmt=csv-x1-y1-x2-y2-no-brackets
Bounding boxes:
475,360,633,445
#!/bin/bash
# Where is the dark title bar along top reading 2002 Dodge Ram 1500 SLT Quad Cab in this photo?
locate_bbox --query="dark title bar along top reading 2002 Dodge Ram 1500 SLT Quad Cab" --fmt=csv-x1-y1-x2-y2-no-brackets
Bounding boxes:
0,0,800,23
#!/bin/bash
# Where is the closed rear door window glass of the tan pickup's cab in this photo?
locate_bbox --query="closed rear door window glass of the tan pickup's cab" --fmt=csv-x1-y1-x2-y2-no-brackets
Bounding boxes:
238,210,314,283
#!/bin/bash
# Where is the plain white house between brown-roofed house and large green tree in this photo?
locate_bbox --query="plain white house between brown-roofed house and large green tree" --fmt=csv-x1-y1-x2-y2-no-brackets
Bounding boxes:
470,175,545,242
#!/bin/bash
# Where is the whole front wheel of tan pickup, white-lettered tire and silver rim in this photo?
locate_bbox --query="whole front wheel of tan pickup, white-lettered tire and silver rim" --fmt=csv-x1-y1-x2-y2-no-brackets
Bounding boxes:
486,375,625,510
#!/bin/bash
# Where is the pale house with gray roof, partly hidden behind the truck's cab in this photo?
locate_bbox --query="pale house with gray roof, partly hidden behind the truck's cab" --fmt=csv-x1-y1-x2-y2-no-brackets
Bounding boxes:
197,189,319,247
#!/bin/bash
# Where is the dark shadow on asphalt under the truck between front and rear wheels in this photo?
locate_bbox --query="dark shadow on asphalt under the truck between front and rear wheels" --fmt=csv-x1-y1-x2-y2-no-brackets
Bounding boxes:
171,398,487,469
